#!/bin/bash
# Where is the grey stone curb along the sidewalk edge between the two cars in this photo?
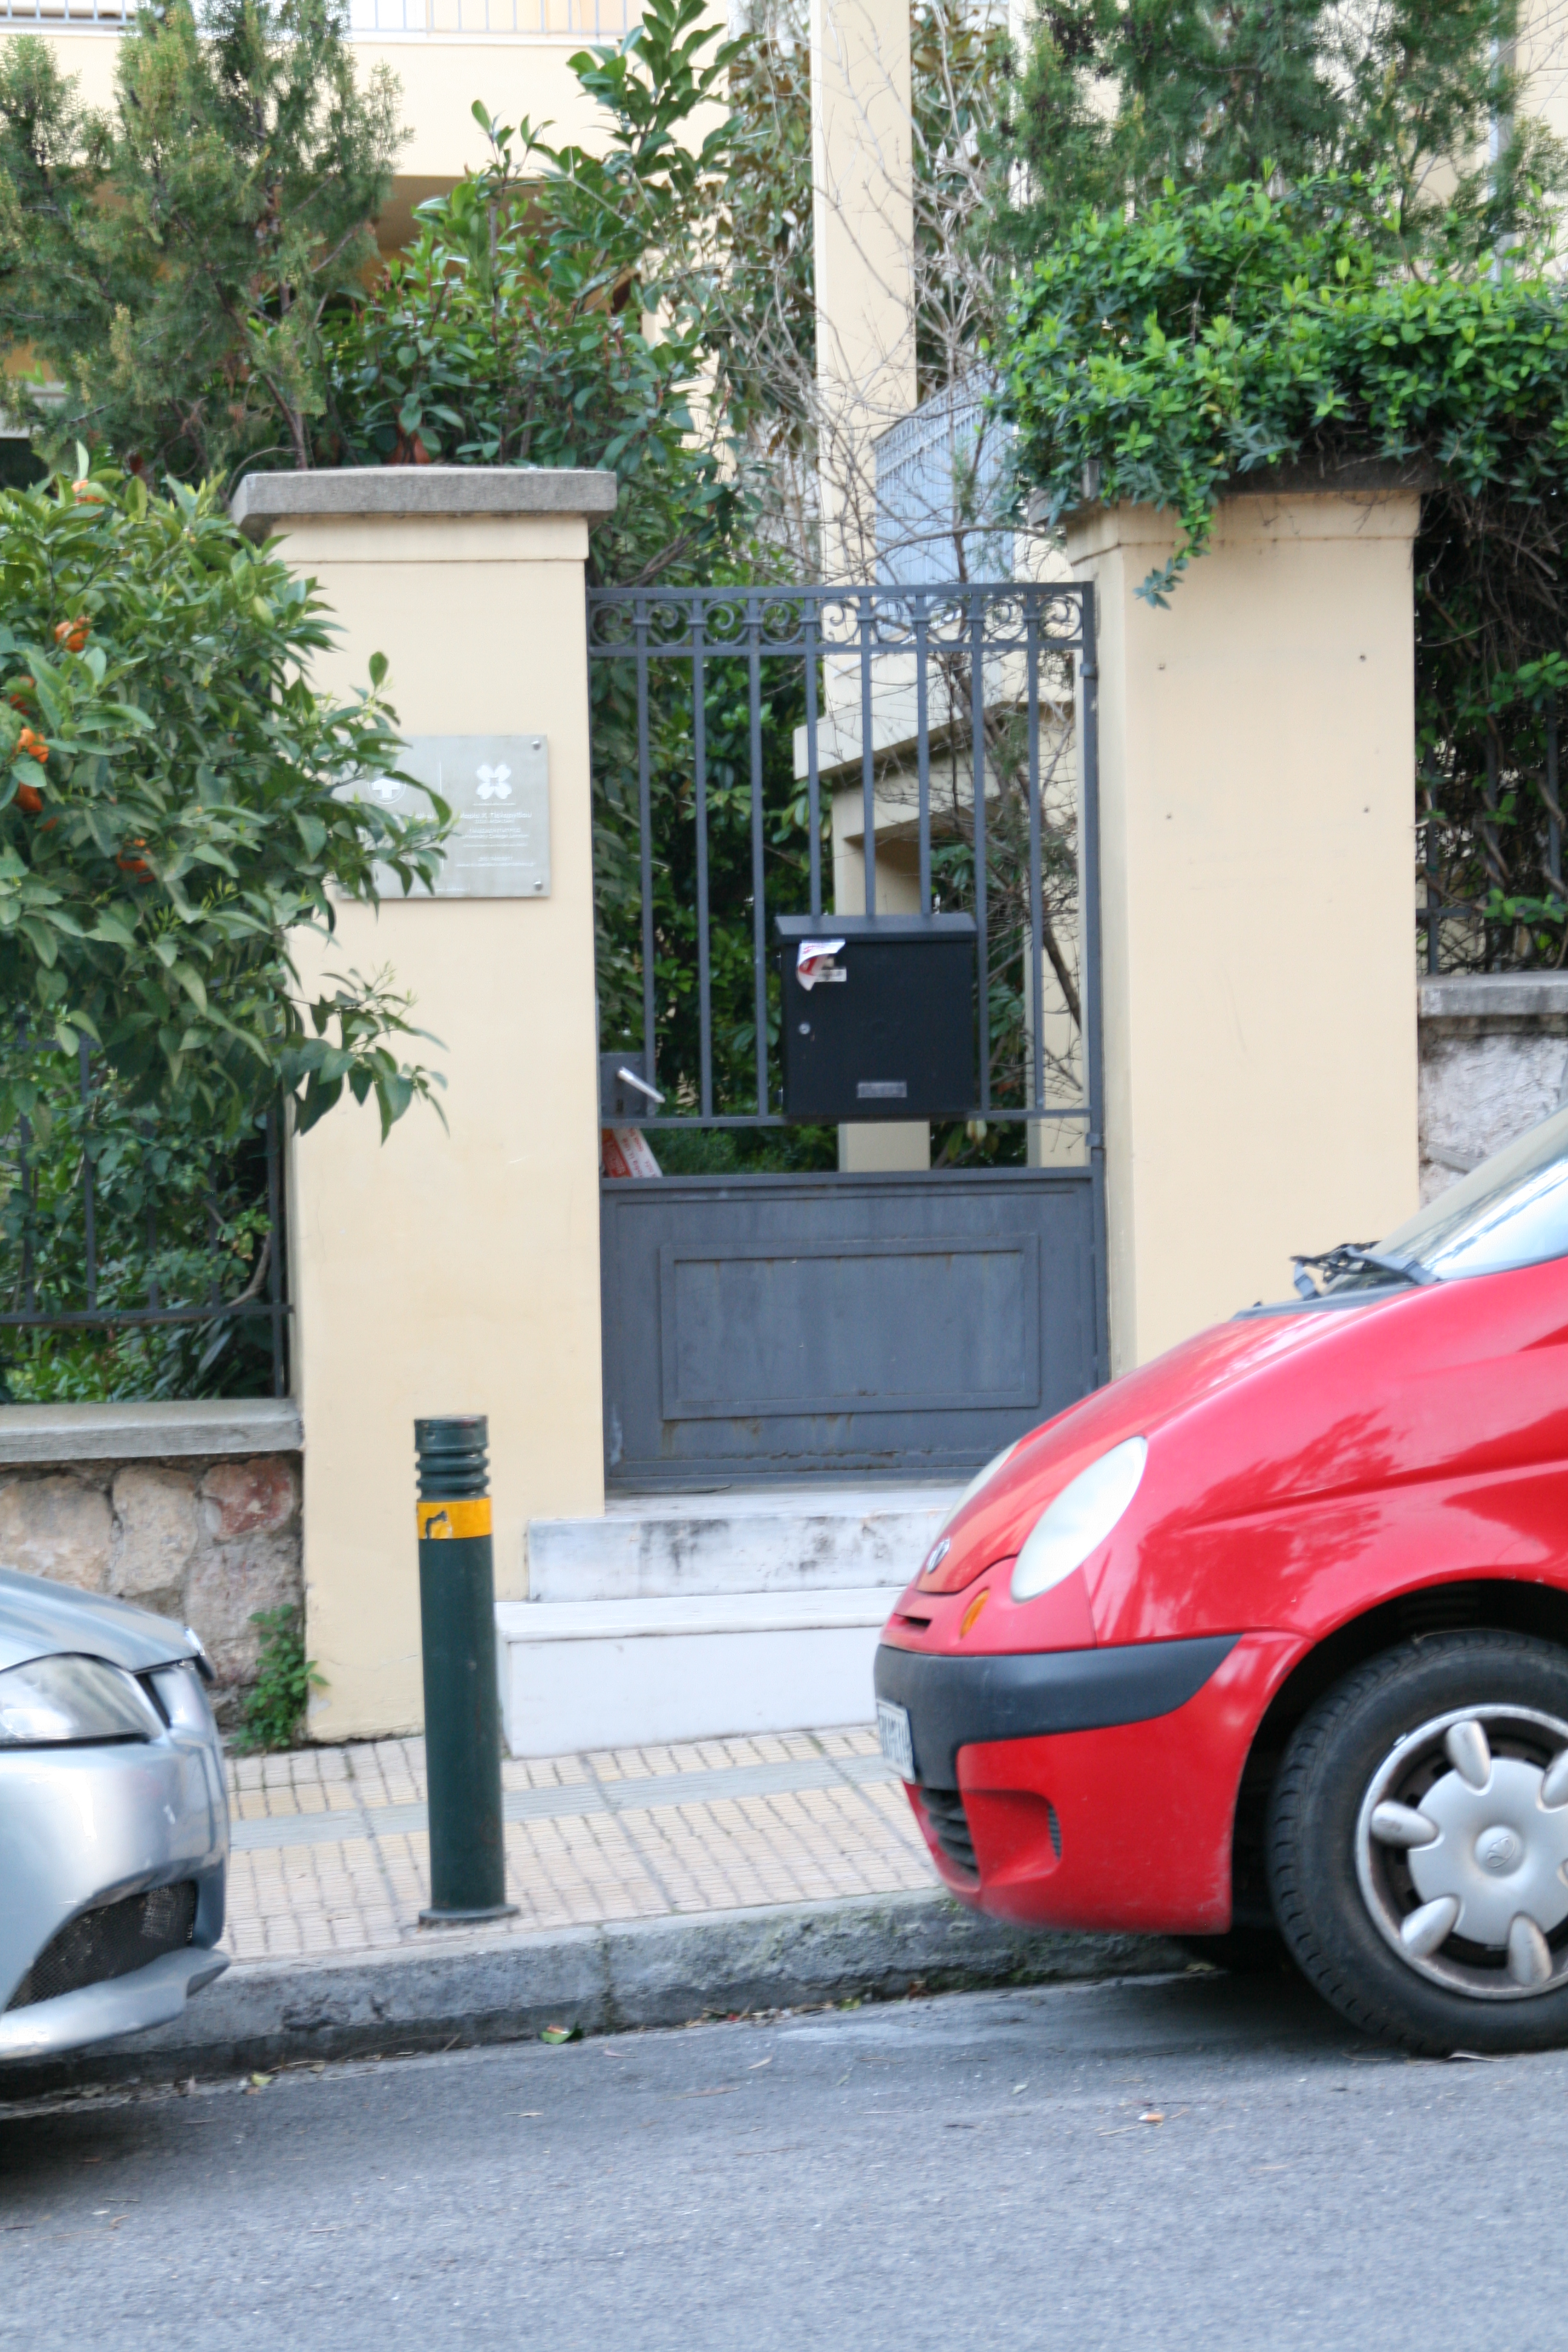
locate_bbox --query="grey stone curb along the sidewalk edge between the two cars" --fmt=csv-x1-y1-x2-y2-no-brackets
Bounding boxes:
0,1891,1187,2098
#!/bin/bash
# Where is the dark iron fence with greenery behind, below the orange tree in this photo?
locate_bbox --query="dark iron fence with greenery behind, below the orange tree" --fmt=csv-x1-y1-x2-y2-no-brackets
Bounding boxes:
0,1044,289,1397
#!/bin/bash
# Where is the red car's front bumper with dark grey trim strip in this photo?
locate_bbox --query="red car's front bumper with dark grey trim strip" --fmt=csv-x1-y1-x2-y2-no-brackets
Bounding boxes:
877,1632,1310,1936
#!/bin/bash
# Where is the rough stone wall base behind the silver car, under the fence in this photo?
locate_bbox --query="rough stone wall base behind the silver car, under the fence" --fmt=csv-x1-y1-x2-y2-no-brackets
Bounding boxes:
0,1454,303,1726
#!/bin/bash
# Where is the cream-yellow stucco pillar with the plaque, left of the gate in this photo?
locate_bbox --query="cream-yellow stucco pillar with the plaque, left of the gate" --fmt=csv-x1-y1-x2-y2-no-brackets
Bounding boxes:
235,466,616,1738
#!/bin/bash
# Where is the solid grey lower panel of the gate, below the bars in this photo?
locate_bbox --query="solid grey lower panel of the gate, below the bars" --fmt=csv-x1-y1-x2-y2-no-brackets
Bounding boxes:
602,1169,1096,1486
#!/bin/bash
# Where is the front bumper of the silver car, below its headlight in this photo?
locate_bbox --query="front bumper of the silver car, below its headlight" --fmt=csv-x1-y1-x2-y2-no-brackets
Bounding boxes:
0,1665,228,2060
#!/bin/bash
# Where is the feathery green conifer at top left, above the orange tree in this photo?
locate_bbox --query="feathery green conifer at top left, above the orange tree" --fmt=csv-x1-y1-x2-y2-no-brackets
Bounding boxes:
0,0,402,480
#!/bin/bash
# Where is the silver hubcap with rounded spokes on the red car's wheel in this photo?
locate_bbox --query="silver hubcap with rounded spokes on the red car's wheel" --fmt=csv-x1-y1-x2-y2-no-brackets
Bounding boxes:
1356,1705,1568,2002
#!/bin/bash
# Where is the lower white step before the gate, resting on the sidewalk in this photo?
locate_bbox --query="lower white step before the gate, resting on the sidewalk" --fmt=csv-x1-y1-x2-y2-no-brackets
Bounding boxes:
496,1576,905,1757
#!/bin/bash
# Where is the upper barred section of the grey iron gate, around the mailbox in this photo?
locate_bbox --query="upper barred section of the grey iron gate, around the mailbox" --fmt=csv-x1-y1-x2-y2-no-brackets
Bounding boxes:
588,581,1100,1150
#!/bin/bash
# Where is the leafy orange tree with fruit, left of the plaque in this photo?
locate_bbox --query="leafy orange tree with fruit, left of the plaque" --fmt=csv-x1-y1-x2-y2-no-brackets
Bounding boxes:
0,459,444,1131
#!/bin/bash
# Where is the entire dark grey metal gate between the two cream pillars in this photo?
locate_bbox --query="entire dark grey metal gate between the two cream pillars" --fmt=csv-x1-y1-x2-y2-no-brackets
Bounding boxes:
588,583,1109,1489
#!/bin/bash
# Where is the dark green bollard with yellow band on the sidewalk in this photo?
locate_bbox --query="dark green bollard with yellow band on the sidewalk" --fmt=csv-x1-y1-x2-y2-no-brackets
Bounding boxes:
414,1414,517,1926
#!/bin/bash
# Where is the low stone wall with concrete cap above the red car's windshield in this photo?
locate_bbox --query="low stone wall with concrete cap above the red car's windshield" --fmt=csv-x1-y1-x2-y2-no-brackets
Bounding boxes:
1420,972,1568,1202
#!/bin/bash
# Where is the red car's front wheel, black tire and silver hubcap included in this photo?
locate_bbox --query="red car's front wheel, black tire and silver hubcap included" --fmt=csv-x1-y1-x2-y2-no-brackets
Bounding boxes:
1267,1632,1568,2051
